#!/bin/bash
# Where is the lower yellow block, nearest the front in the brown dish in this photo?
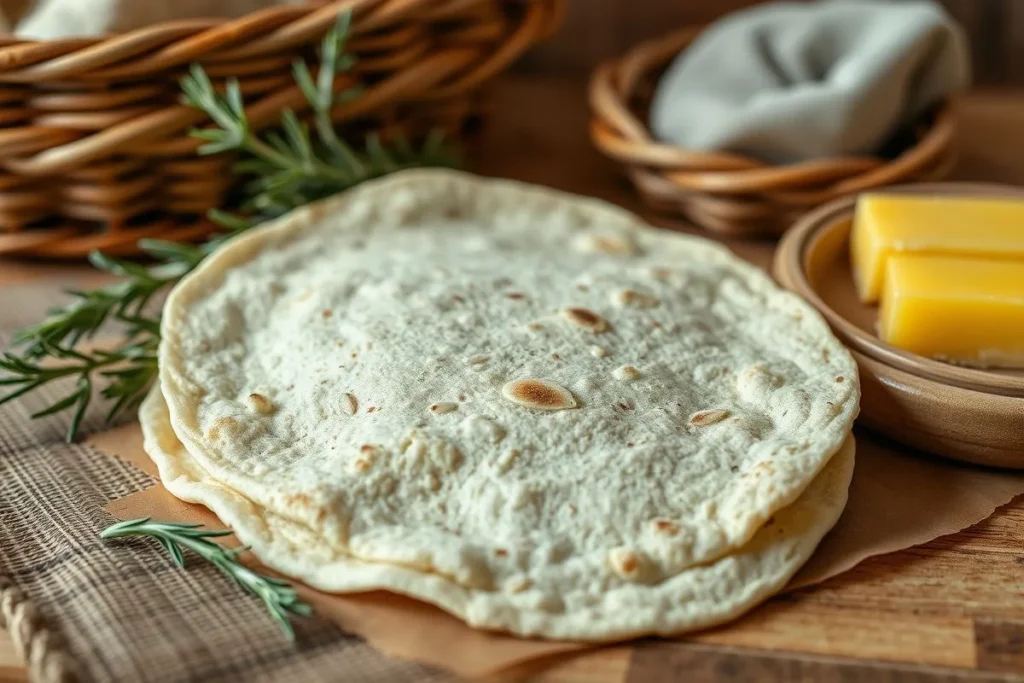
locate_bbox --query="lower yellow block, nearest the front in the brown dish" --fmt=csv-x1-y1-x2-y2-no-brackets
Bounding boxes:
879,253,1024,368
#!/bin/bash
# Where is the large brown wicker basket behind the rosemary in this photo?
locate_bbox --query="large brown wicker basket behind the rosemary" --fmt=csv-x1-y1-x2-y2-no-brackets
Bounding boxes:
0,0,563,258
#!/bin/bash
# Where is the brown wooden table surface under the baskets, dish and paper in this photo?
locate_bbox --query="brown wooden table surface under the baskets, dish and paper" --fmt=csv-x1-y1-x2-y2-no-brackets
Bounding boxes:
0,77,1024,683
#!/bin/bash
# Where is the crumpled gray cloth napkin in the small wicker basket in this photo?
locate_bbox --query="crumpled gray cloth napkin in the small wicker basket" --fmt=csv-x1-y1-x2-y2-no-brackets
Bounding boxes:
650,0,970,164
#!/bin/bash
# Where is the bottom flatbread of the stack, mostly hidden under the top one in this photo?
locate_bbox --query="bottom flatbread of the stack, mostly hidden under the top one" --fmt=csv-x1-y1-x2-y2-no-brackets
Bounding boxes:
139,388,855,641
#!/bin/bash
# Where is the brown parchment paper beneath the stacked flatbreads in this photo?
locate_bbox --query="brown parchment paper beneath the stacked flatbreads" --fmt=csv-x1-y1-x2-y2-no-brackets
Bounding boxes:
87,424,1024,678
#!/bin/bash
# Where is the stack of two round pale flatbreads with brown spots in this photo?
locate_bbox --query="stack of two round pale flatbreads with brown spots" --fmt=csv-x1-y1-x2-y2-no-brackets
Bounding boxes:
141,171,859,640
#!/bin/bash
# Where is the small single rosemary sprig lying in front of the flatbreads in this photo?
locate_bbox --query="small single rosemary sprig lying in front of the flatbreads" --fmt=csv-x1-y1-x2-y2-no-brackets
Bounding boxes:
99,517,312,640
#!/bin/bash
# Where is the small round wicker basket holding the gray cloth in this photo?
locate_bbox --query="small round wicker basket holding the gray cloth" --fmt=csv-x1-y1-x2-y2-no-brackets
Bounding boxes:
590,28,954,237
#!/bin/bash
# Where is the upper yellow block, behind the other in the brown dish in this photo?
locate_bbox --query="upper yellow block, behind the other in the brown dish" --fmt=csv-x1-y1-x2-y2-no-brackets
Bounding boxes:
850,195,1024,303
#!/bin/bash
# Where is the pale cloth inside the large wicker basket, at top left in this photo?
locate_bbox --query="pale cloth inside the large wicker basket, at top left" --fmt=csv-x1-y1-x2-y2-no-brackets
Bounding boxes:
14,0,304,40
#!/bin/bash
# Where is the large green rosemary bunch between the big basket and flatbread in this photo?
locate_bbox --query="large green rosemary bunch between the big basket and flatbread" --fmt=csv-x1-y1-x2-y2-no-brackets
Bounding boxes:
0,14,457,440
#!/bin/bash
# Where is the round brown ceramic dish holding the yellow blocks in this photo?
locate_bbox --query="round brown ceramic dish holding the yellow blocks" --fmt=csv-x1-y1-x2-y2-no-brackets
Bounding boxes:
774,183,1024,468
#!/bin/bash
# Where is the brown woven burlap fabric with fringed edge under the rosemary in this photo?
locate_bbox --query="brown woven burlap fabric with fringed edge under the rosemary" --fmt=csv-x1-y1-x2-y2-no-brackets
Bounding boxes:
0,285,451,683
